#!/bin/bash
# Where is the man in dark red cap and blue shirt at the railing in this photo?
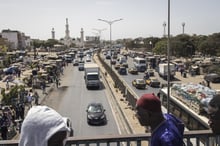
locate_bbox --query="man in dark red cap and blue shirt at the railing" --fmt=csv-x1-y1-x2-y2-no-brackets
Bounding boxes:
136,94,184,146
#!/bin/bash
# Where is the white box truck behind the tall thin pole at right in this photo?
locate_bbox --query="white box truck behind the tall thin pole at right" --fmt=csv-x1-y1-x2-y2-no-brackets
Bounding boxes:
159,63,176,79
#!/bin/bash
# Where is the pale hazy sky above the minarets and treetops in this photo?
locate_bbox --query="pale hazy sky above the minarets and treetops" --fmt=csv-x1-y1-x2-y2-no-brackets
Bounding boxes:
0,0,220,40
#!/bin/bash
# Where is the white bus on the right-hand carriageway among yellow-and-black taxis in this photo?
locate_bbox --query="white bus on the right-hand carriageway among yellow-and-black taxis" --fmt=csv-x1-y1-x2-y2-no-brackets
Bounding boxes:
133,57,147,72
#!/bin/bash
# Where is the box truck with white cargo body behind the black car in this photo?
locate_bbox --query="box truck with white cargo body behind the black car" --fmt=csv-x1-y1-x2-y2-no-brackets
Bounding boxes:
84,63,101,89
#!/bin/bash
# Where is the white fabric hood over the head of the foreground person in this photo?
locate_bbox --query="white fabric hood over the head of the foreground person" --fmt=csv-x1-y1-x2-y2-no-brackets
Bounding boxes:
19,106,70,146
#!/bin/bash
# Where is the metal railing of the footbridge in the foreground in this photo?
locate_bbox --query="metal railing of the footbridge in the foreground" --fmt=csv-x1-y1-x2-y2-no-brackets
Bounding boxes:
0,130,220,146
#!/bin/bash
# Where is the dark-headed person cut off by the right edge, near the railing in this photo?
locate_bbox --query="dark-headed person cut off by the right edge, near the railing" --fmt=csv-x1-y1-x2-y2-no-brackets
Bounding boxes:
208,94,220,134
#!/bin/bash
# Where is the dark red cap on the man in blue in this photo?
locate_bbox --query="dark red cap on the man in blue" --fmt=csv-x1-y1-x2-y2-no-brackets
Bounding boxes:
136,93,161,112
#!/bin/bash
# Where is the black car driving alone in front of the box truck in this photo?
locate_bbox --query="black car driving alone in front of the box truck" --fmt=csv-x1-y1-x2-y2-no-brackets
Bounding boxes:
86,103,107,125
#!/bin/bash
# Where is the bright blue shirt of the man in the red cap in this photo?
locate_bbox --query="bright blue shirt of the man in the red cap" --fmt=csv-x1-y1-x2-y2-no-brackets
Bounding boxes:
150,114,184,146
